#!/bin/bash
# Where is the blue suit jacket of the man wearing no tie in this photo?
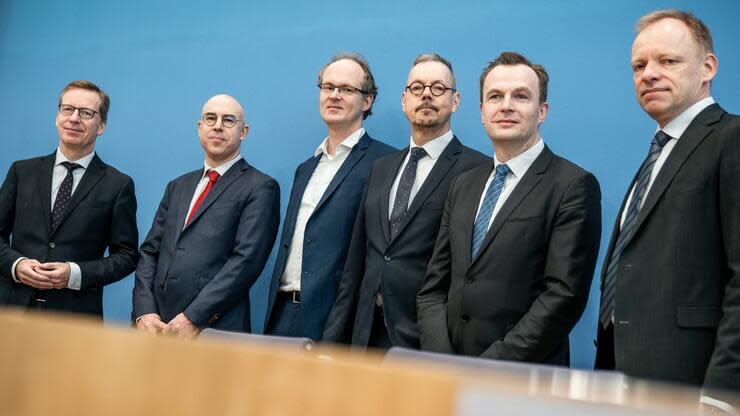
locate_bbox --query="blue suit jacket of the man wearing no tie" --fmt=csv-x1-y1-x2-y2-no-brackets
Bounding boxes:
265,133,395,340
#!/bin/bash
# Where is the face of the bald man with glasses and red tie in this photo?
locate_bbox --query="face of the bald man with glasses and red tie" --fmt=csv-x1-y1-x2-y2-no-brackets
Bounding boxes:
198,95,249,168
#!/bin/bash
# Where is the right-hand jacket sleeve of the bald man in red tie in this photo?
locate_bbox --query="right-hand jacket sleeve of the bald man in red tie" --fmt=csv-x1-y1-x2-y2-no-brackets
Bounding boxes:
184,178,280,328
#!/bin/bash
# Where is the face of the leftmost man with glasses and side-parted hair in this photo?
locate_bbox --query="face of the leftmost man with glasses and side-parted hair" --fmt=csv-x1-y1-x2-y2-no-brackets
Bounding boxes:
56,88,106,159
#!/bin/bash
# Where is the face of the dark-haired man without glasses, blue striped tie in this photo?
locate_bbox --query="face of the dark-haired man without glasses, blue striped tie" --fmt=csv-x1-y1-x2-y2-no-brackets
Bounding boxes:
480,65,548,148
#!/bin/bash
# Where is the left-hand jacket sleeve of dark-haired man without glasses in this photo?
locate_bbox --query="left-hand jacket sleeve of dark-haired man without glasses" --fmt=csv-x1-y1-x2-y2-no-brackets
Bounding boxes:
416,178,457,354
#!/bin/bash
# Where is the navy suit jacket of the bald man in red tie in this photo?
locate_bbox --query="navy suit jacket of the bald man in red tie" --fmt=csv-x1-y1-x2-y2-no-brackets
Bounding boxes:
132,159,280,332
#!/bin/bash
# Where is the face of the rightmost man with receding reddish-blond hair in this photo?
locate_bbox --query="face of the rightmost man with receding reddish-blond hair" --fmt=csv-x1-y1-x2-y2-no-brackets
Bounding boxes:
632,18,717,127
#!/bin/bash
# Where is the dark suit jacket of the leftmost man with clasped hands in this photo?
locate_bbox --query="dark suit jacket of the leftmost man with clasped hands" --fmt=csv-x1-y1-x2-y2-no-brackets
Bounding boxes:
0,152,139,318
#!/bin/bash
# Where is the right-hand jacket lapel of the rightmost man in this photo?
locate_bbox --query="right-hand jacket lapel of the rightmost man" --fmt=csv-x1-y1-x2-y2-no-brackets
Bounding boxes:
632,104,724,238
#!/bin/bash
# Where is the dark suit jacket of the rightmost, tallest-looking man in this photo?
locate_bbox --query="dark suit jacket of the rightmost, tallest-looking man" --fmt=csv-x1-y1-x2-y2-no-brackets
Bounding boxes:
596,104,740,391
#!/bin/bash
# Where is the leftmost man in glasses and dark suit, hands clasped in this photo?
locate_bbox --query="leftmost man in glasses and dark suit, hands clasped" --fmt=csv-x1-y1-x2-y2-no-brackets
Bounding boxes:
0,81,138,318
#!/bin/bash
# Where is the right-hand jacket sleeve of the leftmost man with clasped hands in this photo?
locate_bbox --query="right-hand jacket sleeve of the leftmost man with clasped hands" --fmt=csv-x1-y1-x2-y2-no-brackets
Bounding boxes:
77,177,139,290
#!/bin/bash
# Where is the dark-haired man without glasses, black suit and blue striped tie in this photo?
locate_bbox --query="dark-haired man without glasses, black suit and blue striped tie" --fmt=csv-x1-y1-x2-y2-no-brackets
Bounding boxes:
417,52,601,365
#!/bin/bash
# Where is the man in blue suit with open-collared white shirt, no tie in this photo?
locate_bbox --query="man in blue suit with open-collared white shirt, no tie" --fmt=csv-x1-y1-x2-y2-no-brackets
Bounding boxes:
265,53,395,340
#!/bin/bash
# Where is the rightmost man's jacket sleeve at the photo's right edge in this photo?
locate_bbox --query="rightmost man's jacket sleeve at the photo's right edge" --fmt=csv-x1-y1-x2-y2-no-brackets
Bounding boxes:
704,128,740,395
